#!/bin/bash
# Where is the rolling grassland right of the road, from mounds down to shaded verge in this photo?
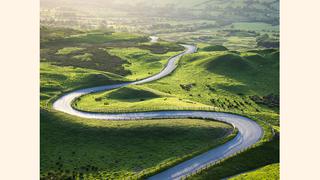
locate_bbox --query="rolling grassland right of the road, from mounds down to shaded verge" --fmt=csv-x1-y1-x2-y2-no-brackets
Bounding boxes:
69,38,279,179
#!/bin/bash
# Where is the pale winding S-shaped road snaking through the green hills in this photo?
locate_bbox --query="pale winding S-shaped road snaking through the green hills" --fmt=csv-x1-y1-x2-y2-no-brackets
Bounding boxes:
53,38,263,180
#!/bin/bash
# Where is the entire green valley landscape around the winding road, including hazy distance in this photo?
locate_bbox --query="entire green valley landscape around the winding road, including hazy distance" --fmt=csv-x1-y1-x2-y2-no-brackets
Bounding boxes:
40,0,280,176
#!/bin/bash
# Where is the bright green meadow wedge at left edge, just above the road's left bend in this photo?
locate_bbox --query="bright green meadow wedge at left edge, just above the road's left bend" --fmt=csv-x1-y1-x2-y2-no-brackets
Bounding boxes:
40,62,126,107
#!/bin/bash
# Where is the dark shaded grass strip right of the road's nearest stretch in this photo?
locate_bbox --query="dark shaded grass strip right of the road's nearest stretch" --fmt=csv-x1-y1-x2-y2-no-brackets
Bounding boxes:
188,135,279,180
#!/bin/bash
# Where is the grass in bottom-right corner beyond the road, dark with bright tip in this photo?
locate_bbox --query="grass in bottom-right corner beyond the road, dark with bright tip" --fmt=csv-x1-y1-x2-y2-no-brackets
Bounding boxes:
187,131,280,180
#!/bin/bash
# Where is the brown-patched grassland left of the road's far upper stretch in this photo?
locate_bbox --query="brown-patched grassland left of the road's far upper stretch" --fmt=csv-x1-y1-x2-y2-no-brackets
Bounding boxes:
41,28,184,80
